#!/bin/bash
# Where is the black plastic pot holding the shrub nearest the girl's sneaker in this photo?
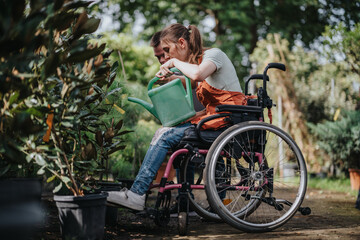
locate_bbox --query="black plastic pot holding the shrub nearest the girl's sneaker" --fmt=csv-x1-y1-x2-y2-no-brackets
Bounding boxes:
54,193,107,240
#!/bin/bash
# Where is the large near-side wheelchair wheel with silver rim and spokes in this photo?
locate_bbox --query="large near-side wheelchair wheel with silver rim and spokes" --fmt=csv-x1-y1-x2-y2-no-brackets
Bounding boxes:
205,121,307,232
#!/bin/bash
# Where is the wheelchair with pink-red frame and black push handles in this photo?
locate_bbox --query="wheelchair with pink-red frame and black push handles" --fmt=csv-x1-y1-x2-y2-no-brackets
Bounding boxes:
126,63,311,235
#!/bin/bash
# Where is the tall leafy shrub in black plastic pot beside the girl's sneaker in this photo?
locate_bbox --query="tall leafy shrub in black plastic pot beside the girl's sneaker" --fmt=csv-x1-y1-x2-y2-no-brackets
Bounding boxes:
35,1,129,239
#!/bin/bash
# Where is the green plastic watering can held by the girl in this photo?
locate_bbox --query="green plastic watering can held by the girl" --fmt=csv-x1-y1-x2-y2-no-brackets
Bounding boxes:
128,68,196,127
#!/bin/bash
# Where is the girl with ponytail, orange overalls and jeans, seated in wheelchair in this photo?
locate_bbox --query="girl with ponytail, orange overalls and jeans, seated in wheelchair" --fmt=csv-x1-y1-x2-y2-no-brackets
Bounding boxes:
108,23,250,211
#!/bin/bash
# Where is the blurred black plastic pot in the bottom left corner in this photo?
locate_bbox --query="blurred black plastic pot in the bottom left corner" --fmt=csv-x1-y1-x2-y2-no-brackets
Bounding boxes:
0,178,45,239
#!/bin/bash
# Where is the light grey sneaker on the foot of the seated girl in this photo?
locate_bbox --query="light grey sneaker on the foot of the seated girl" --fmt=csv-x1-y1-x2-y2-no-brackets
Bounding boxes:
107,188,146,211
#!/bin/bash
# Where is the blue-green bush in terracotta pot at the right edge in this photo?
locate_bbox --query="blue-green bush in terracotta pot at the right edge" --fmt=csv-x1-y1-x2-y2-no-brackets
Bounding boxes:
310,111,360,184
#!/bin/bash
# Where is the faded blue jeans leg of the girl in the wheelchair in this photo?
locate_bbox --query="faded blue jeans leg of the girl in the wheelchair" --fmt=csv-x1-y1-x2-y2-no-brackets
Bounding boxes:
130,123,191,195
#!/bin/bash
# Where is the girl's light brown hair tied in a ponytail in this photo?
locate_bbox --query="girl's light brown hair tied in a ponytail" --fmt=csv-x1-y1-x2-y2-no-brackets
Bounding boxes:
160,23,203,64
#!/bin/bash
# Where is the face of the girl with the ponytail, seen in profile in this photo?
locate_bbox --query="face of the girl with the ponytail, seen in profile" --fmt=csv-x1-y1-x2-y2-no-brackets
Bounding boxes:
161,38,188,62
